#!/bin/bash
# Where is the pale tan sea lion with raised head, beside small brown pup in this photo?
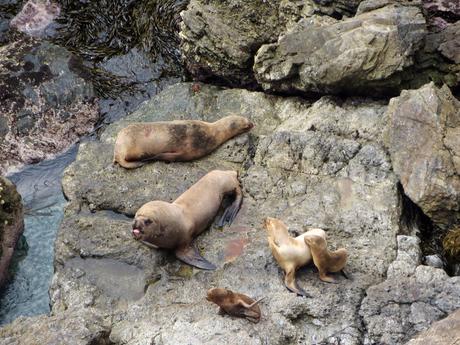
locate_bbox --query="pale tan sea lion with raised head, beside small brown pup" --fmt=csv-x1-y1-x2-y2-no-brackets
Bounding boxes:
264,217,326,297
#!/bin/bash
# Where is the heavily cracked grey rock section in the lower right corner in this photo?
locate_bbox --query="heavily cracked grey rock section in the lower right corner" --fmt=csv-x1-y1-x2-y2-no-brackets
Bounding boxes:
359,232,460,345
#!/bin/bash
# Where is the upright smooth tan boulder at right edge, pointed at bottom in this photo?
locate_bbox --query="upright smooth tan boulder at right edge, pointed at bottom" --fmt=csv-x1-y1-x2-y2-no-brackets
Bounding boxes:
385,83,460,229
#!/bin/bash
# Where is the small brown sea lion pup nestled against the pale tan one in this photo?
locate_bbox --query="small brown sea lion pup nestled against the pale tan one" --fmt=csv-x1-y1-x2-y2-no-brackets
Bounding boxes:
304,233,348,283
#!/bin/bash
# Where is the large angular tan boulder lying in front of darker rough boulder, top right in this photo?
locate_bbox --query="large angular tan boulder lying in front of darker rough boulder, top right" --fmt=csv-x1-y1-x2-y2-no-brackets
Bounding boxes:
254,5,427,95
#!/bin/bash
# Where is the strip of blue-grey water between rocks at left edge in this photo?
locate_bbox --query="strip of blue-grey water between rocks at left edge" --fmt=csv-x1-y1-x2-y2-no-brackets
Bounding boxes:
0,146,78,325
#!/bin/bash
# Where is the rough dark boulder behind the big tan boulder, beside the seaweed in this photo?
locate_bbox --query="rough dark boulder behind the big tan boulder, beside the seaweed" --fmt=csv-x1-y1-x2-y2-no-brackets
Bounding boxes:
180,0,361,87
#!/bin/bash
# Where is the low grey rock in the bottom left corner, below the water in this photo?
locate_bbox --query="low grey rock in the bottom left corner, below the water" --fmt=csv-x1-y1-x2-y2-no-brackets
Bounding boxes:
0,309,109,345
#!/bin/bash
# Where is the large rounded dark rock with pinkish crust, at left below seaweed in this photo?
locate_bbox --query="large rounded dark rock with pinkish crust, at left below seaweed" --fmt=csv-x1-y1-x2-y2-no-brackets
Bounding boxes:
0,38,98,172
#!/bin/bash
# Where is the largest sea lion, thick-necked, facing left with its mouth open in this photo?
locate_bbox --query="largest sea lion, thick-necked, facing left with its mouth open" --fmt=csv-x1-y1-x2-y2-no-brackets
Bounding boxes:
132,170,243,270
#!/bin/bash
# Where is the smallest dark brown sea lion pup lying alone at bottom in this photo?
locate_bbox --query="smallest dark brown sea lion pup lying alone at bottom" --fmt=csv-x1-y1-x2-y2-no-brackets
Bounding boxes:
206,288,265,323
